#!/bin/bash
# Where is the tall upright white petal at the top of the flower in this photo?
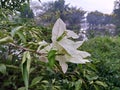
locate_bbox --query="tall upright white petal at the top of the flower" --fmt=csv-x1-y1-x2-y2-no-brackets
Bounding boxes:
52,18,66,42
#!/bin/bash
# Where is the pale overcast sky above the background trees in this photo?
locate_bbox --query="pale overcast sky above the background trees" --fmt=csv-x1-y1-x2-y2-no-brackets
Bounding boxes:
38,0,115,14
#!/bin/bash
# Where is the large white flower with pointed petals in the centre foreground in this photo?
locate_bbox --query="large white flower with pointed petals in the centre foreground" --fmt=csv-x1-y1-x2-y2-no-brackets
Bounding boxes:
52,19,90,73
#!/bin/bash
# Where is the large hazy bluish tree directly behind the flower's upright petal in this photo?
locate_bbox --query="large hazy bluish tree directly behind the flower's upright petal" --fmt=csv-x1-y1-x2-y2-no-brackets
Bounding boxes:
36,0,86,30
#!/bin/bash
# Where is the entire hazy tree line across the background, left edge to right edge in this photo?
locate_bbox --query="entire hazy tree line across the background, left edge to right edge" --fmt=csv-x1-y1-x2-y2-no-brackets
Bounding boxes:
1,0,120,35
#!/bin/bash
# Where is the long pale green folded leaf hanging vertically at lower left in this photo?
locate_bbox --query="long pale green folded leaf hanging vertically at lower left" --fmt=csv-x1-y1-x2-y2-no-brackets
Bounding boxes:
21,51,31,90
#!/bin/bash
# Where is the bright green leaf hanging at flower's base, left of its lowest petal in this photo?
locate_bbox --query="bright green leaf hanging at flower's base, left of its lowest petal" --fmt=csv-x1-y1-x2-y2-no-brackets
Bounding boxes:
48,50,56,68
